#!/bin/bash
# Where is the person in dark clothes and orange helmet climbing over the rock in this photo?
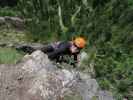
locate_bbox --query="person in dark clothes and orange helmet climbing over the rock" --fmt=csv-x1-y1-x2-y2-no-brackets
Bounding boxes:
17,37,86,63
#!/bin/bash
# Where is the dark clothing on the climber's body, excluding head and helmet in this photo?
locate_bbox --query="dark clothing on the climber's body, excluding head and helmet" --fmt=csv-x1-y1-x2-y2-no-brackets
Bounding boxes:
16,41,80,61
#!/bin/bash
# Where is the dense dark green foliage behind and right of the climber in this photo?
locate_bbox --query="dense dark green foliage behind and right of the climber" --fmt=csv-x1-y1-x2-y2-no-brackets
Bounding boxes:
0,0,133,100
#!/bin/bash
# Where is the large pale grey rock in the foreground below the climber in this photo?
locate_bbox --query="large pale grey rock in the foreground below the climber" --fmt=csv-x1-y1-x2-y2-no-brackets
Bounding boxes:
0,51,113,100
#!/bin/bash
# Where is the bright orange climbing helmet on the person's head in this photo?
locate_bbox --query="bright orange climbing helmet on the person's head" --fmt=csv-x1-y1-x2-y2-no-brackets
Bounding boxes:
74,37,86,48
